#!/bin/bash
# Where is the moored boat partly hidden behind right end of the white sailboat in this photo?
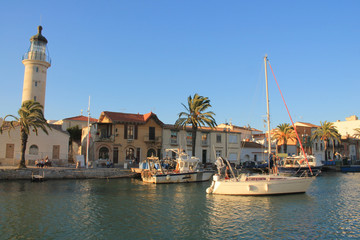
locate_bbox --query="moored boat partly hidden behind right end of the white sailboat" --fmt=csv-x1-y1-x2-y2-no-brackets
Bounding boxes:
278,155,323,175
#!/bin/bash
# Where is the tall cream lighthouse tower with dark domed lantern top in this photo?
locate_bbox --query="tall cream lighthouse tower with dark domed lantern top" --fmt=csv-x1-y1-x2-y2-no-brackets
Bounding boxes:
22,26,51,111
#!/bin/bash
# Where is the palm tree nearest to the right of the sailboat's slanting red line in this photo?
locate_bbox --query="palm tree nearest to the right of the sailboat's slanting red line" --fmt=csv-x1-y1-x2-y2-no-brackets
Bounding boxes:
311,121,341,161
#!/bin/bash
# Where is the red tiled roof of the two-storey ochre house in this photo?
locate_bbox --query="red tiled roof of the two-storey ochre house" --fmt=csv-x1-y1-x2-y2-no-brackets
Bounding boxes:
100,111,163,125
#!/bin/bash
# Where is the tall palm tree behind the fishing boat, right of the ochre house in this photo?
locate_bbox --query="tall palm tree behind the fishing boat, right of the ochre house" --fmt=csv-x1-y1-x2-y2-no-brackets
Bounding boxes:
175,93,216,156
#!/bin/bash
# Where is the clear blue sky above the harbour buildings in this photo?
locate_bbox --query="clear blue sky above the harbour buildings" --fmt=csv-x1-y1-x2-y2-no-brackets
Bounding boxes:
0,0,360,130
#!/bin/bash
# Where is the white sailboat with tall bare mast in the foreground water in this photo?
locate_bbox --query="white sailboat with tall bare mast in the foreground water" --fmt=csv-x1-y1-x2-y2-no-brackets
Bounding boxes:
206,56,315,196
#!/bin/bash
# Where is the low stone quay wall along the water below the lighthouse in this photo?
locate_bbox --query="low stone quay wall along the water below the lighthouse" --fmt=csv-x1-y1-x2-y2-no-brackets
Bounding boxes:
0,168,134,180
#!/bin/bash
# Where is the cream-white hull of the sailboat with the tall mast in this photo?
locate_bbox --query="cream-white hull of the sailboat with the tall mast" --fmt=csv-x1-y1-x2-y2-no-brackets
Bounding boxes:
206,176,314,196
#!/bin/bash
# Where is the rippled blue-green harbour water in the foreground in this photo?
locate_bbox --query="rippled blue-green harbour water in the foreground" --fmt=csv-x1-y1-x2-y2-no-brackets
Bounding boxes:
0,173,360,239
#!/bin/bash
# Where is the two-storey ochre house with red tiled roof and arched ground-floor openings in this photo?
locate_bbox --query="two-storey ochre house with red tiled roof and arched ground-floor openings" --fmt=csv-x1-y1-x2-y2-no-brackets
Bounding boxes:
83,111,164,165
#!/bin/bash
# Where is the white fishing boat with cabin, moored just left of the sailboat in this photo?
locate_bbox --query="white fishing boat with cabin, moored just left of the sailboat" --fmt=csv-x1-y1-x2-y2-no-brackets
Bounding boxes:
141,149,214,184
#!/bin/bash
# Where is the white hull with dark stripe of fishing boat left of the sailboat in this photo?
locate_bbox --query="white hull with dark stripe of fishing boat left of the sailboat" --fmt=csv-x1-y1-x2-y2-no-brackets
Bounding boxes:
141,171,214,184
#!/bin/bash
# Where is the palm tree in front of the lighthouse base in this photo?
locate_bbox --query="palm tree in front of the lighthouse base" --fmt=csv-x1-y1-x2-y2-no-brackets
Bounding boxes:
0,100,51,168
